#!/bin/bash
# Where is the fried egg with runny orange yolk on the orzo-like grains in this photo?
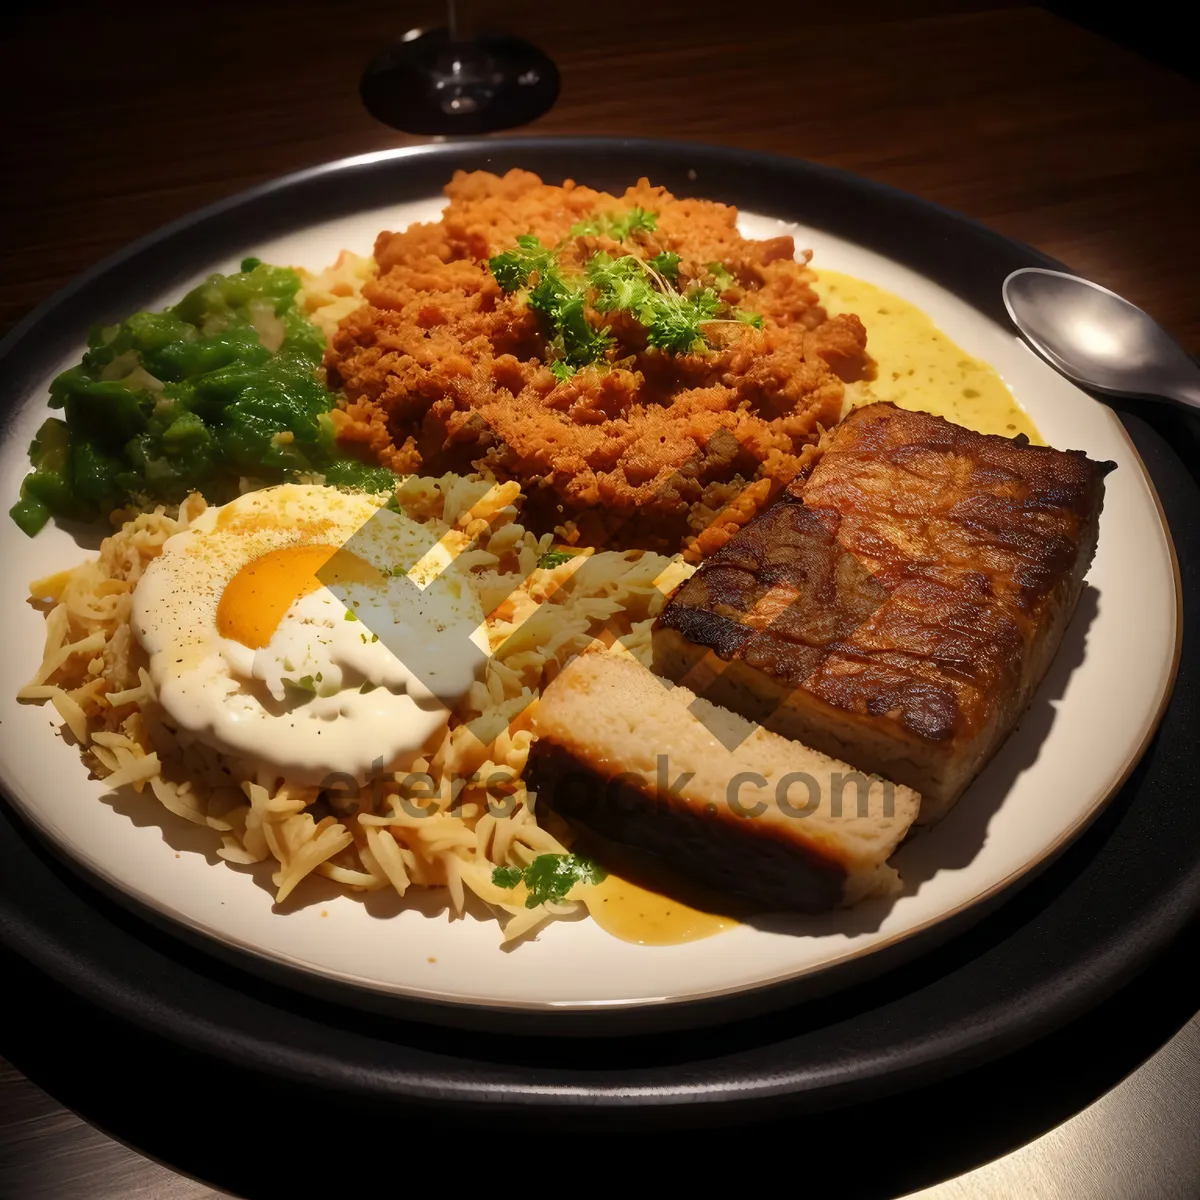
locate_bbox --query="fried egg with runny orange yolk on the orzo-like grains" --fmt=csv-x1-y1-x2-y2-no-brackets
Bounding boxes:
132,484,487,787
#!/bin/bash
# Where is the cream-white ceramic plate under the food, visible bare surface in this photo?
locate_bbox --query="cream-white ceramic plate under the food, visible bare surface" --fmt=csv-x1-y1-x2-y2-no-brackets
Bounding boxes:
0,197,1178,1009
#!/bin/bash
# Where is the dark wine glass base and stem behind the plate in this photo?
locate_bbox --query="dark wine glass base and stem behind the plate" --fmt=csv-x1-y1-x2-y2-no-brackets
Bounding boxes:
359,0,558,134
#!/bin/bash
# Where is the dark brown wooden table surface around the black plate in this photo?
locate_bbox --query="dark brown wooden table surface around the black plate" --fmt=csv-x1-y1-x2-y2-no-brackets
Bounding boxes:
0,0,1200,1200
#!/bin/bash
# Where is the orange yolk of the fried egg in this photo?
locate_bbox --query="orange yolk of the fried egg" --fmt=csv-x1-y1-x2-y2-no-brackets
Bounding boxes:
217,546,383,650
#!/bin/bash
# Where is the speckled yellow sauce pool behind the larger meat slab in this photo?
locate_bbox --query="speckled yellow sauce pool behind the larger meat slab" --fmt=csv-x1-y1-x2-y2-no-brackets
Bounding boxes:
816,271,1043,445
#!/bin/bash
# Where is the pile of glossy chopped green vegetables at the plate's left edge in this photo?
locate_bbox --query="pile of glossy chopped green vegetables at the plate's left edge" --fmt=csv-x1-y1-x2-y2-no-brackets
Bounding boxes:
11,258,395,535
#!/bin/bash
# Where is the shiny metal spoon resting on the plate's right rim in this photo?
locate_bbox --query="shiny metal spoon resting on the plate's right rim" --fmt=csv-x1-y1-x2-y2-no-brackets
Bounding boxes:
1003,266,1200,409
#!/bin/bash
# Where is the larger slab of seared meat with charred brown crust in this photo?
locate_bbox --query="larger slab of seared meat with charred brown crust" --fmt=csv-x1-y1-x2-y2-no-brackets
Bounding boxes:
654,404,1112,822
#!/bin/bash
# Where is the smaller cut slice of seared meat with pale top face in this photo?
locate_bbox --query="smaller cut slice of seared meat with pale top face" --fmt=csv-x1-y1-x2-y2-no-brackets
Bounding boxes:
528,653,920,912
